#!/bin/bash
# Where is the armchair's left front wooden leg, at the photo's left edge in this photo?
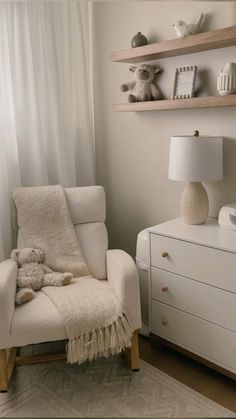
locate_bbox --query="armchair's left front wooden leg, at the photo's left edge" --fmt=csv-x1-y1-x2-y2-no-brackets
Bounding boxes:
0,348,16,393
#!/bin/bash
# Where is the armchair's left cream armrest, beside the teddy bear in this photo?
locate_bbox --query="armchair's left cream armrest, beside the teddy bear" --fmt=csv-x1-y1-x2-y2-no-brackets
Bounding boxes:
0,259,18,349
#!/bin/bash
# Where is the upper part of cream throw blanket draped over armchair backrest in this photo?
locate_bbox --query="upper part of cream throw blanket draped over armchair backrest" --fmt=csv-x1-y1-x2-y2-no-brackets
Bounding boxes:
13,185,89,276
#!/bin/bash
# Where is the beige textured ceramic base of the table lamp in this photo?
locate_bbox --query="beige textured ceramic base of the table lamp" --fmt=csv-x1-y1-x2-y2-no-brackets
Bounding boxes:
180,182,209,224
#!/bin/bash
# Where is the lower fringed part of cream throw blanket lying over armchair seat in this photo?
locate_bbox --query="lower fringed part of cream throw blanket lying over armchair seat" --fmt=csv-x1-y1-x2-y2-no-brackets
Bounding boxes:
42,277,134,363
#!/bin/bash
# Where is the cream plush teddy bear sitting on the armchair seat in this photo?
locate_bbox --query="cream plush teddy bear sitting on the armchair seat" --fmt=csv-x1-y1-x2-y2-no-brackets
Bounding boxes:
11,248,73,304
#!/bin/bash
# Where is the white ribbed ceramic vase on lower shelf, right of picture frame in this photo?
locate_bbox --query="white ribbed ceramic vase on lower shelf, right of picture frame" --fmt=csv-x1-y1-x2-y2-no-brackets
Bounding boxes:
217,63,236,96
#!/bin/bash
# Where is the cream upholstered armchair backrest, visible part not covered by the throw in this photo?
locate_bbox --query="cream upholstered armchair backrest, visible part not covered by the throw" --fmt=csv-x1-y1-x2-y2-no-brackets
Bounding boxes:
13,186,108,279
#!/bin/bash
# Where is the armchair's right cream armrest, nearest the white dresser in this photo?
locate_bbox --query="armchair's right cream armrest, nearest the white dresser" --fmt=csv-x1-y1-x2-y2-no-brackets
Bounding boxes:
106,250,142,329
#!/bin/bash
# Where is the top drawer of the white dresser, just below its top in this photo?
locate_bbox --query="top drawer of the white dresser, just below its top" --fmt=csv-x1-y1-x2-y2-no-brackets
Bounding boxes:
151,234,236,293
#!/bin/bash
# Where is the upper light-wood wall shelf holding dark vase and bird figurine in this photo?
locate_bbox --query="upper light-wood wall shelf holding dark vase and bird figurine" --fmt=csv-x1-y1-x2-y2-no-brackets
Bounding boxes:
111,26,236,63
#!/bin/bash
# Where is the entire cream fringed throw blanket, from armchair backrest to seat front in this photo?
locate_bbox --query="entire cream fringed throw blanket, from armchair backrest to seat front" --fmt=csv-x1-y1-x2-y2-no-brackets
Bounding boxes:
13,186,134,363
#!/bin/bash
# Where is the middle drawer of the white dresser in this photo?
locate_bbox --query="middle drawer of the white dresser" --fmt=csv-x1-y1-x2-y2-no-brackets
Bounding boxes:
151,268,236,332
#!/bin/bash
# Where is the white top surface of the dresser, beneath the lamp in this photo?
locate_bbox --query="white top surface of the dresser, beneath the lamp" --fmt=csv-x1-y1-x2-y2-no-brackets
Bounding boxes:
148,218,236,253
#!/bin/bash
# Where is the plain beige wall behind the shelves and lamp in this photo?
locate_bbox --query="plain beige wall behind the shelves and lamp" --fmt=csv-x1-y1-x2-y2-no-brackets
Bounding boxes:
94,0,236,255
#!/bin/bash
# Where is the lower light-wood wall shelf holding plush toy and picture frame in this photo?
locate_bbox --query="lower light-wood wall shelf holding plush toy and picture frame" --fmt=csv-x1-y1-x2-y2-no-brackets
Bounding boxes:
113,94,236,112
